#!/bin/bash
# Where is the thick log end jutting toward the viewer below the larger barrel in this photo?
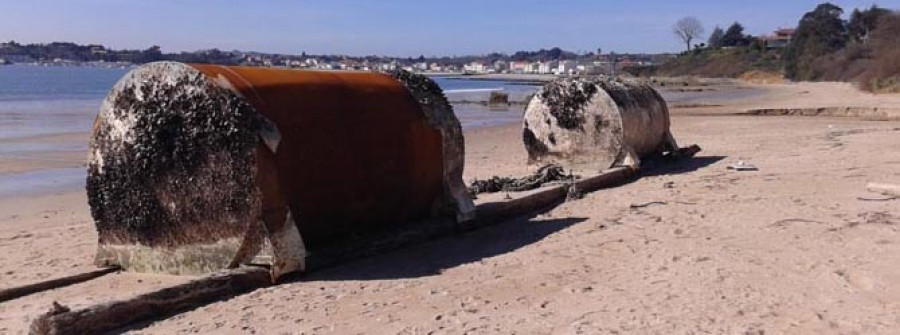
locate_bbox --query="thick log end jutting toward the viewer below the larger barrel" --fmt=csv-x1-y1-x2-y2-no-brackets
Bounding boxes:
30,267,272,335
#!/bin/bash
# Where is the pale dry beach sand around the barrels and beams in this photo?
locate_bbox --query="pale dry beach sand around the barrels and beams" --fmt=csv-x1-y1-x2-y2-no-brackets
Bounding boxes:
0,80,900,334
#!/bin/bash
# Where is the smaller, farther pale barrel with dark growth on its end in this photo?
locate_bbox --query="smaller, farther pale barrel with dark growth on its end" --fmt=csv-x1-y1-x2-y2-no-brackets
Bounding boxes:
522,78,677,171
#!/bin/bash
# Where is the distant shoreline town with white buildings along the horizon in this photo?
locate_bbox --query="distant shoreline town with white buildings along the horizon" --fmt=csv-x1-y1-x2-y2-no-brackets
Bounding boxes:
0,41,675,75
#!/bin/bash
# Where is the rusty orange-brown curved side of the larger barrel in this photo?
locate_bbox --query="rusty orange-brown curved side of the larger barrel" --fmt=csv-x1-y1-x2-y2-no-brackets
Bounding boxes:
193,65,442,249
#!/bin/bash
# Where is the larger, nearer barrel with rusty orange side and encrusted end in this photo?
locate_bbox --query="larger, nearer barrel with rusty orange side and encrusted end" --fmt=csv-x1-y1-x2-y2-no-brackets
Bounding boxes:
87,62,474,277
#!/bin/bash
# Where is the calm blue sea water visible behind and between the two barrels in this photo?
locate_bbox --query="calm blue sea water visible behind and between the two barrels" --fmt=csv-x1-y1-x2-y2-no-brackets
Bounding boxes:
0,65,537,197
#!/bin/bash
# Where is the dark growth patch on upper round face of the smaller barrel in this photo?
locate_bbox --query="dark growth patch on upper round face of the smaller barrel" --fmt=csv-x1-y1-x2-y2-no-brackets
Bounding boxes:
540,79,598,130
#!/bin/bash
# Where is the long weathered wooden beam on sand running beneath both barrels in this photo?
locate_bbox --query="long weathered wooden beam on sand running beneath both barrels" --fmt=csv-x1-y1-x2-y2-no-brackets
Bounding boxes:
24,168,637,335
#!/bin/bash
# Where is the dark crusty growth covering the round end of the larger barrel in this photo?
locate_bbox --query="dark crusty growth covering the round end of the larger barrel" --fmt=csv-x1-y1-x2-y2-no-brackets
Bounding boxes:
87,73,258,245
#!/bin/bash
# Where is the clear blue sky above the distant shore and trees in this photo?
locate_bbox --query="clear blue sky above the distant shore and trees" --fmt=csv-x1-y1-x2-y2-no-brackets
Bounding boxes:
0,0,897,56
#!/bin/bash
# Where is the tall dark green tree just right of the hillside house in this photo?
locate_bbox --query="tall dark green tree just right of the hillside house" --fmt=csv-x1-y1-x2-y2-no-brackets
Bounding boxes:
785,3,847,80
